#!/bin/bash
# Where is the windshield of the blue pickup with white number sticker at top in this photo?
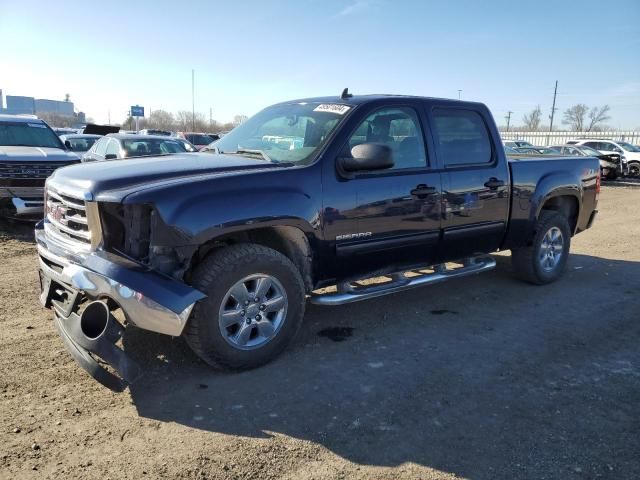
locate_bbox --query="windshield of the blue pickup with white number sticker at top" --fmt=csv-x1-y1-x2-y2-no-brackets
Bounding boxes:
215,103,351,164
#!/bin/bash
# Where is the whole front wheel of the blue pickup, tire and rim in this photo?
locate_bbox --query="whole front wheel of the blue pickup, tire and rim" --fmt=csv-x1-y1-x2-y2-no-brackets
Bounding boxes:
184,244,305,369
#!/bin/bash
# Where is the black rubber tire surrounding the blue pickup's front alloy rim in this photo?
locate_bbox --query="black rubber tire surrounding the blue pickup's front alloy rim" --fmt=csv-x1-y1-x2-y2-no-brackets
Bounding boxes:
183,243,305,369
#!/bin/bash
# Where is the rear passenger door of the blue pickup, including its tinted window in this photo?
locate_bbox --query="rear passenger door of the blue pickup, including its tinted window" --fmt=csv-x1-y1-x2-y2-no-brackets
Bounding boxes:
430,106,510,260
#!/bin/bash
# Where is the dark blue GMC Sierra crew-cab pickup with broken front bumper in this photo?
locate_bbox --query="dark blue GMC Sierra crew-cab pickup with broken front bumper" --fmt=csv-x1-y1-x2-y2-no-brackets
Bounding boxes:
35,94,600,389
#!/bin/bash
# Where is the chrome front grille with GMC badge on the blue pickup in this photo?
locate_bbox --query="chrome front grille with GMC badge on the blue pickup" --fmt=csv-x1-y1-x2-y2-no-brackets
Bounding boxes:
45,189,91,247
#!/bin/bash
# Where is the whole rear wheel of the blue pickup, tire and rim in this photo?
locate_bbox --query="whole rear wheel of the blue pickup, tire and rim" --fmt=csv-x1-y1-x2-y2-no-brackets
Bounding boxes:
511,210,571,285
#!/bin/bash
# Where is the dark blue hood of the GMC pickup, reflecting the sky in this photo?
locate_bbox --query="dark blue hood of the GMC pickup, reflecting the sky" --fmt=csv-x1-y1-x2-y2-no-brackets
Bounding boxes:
47,153,280,202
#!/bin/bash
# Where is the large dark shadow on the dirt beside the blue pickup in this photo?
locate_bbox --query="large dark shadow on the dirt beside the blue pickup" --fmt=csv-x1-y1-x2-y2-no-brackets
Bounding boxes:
124,255,640,478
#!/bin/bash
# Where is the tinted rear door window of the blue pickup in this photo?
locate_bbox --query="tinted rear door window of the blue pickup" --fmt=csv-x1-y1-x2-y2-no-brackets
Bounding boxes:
433,108,493,167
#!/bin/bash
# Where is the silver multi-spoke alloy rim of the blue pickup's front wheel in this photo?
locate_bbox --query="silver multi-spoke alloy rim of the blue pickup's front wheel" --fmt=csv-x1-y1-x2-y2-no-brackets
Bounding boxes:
218,273,287,350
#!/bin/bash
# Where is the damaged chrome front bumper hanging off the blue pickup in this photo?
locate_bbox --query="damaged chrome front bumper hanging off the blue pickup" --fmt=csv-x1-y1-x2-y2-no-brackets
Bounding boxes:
35,222,205,391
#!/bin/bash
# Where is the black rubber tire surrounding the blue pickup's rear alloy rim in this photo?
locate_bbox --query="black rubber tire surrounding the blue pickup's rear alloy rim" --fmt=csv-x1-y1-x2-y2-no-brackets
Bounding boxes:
511,210,571,285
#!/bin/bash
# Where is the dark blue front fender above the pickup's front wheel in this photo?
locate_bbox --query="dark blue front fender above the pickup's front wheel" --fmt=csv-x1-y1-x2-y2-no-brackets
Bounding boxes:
120,168,322,246
